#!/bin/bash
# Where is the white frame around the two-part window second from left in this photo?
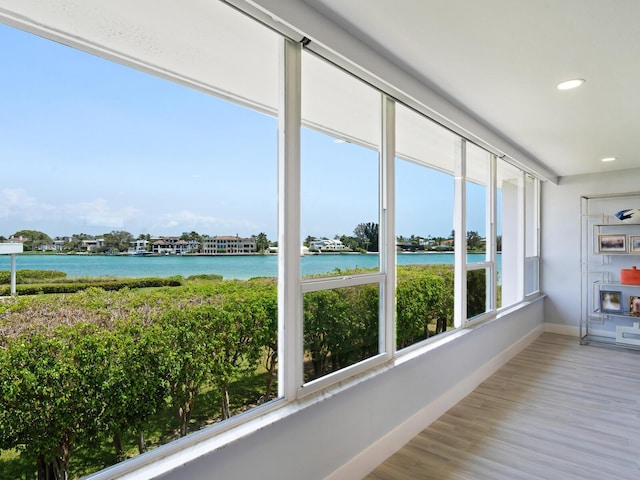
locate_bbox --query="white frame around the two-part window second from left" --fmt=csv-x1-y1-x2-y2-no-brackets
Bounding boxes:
292,45,395,399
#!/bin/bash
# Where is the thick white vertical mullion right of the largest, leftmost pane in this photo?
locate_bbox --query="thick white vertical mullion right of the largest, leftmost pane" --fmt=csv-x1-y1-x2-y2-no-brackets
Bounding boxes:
278,38,303,400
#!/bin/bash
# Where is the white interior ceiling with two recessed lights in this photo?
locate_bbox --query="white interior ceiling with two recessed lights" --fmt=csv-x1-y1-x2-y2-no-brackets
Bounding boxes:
306,0,640,176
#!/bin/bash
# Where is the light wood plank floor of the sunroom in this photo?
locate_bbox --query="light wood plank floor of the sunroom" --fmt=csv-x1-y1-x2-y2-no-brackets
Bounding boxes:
366,333,640,480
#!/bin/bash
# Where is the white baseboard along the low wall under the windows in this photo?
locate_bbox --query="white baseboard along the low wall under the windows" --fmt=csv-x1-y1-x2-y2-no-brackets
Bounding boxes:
325,325,545,480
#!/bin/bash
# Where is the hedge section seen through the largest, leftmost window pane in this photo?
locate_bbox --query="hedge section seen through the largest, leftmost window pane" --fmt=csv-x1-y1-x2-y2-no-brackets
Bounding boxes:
0,279,278,478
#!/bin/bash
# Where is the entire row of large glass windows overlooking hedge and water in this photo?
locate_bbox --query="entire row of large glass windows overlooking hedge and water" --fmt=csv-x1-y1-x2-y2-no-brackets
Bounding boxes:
0,2,539,478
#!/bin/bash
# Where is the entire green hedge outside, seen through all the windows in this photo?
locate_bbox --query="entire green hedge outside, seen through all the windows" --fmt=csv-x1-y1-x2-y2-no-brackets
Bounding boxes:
0,265,485,477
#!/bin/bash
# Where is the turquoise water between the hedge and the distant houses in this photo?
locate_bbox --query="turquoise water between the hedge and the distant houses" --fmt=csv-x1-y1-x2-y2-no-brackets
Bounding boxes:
0,253,500,279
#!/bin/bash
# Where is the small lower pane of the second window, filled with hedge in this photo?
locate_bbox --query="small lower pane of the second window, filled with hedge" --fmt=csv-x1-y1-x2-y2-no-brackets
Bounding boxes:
303,284,380,382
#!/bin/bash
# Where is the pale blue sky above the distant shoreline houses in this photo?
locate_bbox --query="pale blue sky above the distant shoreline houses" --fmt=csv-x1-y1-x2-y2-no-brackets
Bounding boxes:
0,25,484,240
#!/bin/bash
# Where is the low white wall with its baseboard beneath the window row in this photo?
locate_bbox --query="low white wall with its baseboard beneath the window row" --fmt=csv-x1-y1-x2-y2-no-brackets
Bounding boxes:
152,299,544,480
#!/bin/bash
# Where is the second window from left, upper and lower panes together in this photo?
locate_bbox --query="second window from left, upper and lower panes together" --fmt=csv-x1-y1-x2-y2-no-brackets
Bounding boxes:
300,52,382,382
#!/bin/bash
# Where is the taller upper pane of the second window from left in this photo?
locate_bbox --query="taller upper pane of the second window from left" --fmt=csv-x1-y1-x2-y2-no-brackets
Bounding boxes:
301,52,381,275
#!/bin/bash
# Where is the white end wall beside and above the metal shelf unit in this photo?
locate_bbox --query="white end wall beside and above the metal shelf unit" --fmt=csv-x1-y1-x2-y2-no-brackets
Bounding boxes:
540,169,640,336
